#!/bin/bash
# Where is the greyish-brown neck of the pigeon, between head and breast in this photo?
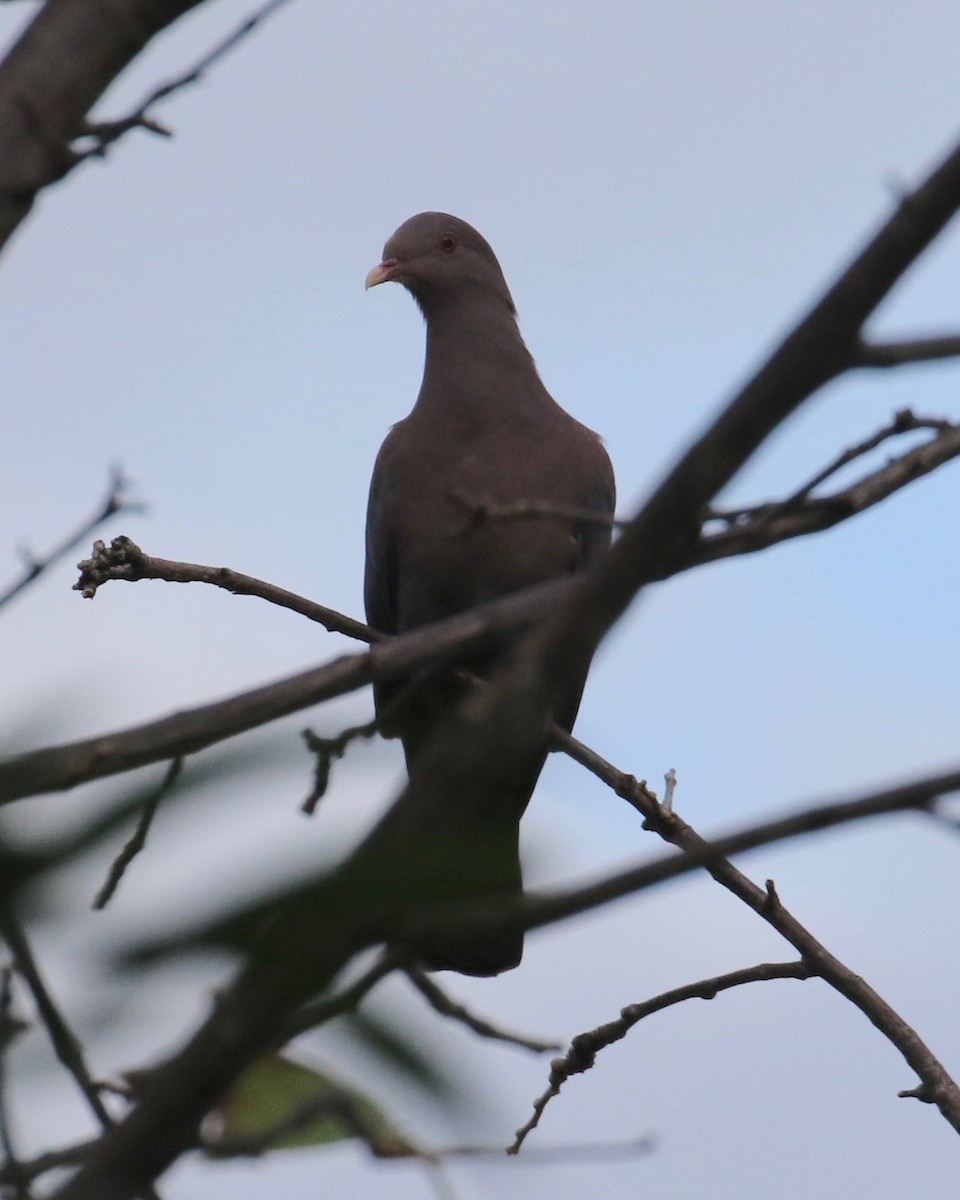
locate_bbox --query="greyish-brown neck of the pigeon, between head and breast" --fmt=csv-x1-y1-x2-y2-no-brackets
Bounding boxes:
416,294,548,415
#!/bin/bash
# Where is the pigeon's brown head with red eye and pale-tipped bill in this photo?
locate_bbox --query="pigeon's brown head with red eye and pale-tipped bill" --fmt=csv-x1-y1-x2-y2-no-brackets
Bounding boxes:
366,212,515,314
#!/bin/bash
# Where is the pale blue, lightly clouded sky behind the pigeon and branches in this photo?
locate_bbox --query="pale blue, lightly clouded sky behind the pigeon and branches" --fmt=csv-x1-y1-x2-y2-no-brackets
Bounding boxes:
0,0,960,1200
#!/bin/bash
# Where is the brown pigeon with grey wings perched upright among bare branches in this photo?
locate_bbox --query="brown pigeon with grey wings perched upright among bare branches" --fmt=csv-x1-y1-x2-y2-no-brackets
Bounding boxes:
364,212,616,976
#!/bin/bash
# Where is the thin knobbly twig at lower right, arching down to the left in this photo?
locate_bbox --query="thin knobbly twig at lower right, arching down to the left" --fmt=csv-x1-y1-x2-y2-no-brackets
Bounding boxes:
506,959,816,1154
